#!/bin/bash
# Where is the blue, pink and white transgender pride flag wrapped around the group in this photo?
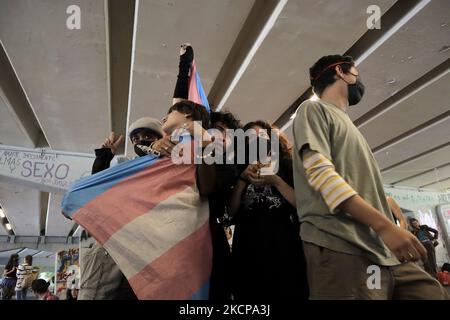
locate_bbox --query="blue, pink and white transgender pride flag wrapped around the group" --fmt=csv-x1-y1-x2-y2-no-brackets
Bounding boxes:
62,64,212,300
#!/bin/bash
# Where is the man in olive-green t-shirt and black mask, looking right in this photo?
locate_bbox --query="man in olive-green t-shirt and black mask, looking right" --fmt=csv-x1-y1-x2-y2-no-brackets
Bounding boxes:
293,55,448,299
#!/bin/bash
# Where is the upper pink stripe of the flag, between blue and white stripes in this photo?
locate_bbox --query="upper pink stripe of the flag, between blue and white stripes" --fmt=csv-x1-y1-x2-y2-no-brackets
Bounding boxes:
74,158,196,245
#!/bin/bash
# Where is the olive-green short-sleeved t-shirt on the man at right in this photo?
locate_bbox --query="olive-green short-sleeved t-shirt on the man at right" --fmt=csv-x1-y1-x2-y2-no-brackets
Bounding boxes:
293,100,400,266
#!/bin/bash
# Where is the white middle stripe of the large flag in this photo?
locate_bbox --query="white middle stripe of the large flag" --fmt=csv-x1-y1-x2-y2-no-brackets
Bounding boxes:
104,187,209,279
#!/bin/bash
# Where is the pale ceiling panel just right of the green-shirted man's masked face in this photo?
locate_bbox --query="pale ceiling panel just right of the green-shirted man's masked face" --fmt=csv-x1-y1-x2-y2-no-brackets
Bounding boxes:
349,0,450,119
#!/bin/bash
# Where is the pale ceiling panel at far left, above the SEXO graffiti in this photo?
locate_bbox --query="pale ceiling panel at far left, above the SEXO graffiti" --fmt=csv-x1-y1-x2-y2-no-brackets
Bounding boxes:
0,0,110,152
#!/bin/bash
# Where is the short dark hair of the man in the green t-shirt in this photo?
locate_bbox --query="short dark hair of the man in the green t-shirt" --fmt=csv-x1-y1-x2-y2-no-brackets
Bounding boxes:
309,54,355,97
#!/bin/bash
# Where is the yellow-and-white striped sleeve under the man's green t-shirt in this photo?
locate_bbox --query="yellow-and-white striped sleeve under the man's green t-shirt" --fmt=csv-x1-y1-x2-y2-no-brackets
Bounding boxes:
302,149,357,213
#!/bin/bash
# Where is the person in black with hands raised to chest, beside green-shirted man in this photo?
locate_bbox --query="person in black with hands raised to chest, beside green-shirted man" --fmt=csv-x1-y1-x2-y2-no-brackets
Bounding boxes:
230,121,308,300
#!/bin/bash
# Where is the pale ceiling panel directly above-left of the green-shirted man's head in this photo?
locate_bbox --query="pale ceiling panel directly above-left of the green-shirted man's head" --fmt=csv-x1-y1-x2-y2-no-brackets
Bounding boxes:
225,0,395,123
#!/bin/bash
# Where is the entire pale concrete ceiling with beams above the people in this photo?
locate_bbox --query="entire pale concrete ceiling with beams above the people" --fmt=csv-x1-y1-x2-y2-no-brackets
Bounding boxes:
0,0,450,236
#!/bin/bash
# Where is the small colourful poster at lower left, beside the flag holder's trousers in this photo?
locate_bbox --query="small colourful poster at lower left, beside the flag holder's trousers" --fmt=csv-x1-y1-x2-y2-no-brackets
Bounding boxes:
55,248,80,300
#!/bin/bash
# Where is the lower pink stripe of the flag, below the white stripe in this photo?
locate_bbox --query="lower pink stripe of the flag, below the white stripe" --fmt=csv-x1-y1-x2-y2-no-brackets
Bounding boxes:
128,220,212,300
